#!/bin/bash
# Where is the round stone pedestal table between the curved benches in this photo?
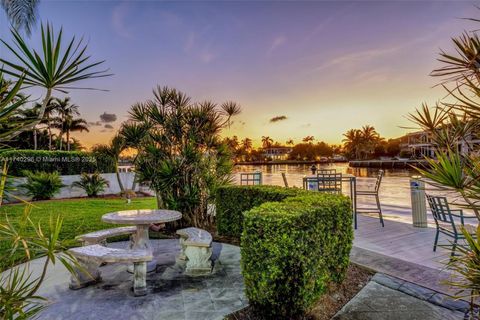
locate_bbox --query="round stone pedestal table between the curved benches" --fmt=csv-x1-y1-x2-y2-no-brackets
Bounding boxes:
102,209,182,272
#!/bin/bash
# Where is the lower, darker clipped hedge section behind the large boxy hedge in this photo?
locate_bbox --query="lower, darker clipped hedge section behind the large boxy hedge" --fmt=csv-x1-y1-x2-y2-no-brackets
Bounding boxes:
215,185,306,238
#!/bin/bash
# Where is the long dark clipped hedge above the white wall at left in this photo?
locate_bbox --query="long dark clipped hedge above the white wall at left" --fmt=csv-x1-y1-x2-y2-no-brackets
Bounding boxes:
0,150,115,177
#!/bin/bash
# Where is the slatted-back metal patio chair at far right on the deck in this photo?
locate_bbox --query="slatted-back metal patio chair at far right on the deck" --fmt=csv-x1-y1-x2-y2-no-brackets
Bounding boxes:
426,194,477,257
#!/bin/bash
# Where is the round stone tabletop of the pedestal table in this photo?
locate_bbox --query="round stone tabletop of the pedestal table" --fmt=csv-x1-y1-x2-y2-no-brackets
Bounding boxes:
102,209,182,225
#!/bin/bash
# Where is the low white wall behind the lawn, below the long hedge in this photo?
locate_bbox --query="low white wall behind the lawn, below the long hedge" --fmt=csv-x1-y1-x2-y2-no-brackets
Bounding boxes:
7,172,153,200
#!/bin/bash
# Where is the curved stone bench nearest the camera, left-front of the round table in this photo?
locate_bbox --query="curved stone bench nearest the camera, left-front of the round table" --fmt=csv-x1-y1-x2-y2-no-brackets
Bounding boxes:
69,244,153,296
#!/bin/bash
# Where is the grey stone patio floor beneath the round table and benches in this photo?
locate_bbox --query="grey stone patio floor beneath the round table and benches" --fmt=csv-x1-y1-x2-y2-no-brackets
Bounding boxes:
36,240,248,320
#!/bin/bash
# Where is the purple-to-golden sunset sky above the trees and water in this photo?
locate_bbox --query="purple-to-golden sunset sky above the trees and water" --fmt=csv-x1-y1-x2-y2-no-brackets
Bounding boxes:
0,0,474,146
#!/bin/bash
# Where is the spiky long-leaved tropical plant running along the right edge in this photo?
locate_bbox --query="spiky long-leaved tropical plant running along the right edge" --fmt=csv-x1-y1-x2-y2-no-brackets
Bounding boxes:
409,8,480,319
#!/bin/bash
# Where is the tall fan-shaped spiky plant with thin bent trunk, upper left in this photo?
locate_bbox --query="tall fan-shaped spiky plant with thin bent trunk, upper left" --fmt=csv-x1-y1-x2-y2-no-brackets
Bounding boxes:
0,24,109,139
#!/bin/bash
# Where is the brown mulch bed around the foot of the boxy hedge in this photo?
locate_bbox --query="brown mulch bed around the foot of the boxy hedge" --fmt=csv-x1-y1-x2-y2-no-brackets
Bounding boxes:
226,264,373,320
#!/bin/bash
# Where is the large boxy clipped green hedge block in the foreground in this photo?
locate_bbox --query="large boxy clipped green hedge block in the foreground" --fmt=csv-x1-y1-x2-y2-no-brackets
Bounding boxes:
242,194,353,319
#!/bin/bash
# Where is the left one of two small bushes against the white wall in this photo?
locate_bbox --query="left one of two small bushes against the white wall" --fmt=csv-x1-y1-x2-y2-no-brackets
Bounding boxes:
20,170,64,200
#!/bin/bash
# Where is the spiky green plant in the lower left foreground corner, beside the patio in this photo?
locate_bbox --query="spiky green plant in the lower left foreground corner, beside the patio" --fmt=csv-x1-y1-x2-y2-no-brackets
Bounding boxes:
0,205,78,319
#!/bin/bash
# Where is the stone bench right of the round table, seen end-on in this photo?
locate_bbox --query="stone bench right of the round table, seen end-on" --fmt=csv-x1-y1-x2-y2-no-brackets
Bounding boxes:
177,227,212,275
